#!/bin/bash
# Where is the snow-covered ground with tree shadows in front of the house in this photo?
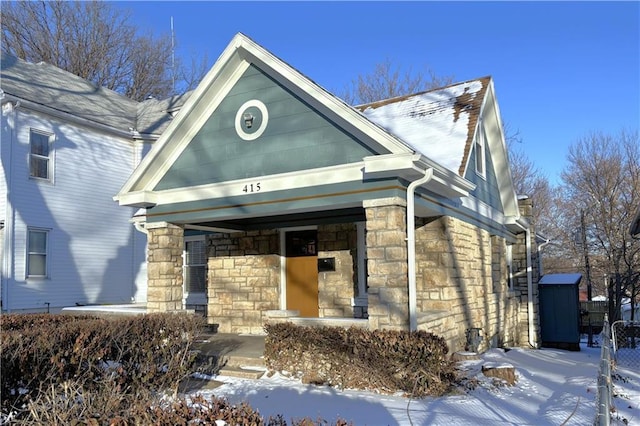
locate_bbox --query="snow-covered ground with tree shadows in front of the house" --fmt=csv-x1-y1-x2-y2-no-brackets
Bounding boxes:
192,345,640,426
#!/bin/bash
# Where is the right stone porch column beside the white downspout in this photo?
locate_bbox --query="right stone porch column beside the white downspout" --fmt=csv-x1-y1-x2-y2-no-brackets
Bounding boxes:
364,198,409,330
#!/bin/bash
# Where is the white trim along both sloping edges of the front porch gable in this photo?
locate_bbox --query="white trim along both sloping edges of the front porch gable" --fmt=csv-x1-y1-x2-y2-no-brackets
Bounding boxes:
115,33,473,206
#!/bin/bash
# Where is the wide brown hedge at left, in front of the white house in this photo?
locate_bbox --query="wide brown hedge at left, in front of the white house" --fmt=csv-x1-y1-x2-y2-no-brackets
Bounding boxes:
0,314,202,413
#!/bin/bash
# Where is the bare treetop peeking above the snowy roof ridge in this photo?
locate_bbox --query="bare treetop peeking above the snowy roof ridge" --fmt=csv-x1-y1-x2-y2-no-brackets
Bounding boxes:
339,59,453,105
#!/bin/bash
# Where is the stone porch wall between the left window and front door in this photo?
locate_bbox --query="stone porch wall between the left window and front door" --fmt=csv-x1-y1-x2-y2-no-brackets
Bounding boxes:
207,230,280,334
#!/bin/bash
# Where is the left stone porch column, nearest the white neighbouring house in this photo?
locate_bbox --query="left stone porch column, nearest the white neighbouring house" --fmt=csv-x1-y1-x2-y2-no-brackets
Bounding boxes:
146,222,184,312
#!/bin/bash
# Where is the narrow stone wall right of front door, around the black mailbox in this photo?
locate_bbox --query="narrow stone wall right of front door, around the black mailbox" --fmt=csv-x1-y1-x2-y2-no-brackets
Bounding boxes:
318,223,358,318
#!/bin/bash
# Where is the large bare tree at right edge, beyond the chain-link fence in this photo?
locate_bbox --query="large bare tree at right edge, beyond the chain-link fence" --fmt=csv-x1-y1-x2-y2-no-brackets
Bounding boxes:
558,131,640,320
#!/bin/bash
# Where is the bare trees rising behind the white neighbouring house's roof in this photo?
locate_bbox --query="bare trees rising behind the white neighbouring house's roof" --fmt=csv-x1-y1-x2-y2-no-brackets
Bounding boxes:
0,0,204,100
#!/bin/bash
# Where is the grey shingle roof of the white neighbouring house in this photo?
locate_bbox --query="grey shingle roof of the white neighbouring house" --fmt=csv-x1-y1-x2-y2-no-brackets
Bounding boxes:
0,52,181,136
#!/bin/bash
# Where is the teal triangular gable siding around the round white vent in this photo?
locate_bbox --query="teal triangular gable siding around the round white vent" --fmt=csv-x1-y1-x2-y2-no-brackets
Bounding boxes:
154,66,375,190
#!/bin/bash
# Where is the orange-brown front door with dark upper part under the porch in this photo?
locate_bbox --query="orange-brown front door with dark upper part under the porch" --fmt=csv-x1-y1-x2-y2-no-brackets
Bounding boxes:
285,229,318,318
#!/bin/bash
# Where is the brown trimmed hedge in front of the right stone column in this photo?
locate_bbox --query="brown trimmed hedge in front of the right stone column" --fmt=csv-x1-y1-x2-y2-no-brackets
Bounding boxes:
264,323,456,397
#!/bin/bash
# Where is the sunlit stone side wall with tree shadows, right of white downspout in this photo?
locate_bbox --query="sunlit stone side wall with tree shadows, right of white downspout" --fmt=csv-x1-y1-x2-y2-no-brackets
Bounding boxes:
416,217,515,352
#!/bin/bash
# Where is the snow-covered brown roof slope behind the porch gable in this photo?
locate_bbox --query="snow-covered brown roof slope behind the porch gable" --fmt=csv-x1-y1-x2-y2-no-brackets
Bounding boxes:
358,77,490,175
